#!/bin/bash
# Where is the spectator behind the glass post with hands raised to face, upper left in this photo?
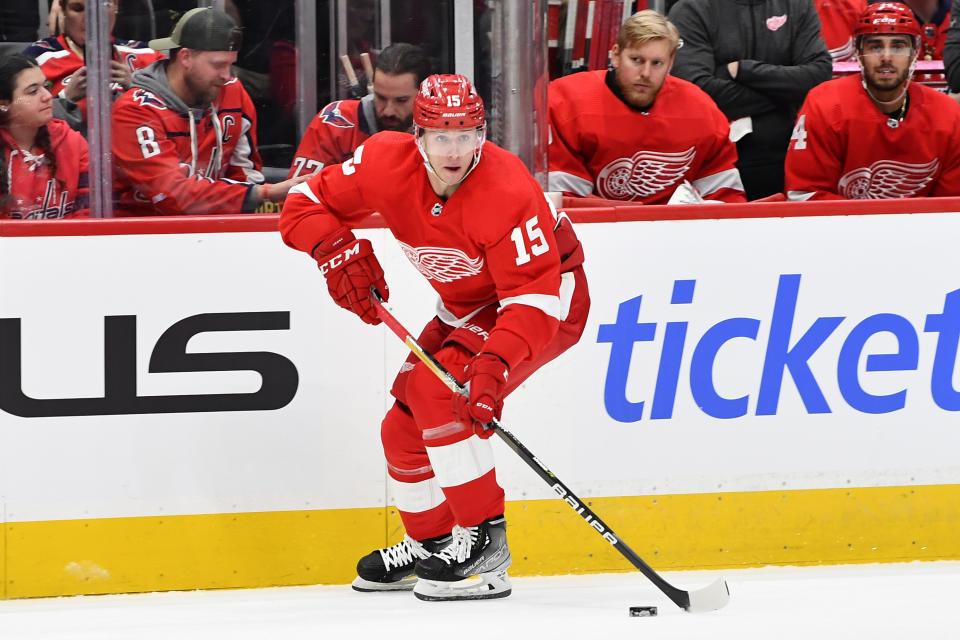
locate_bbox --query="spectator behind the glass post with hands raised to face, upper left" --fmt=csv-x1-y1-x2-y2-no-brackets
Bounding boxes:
24,0,163,131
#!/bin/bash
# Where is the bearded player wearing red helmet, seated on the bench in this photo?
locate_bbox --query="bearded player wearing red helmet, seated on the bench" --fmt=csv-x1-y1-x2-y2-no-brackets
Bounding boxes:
786,2,960,200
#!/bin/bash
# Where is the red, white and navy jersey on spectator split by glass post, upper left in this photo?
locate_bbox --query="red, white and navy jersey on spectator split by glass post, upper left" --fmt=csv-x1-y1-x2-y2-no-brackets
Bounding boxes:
24,34,165,120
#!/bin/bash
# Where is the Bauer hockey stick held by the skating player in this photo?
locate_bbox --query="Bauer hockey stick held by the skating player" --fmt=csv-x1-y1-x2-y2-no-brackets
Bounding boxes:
370,287,730,613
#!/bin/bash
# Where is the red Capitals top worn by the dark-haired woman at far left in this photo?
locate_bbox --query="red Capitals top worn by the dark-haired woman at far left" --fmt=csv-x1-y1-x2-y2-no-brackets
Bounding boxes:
0,120,90,220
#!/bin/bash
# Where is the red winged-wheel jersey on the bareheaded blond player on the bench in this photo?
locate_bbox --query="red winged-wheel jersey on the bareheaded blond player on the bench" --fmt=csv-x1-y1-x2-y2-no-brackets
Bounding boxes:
548,70,746,204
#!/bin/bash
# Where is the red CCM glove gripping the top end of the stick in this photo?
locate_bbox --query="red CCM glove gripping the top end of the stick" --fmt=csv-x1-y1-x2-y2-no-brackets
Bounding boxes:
313,227,390,324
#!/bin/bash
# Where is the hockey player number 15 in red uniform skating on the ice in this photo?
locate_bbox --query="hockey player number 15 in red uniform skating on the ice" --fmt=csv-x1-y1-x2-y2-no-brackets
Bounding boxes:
280,75,589,600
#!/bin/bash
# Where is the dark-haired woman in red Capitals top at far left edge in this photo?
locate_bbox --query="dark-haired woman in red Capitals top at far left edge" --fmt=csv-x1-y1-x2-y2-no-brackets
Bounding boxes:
0,54,89,220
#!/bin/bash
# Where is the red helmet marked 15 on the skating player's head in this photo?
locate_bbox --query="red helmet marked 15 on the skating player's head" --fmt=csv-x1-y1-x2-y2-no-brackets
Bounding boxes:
413,73,484,129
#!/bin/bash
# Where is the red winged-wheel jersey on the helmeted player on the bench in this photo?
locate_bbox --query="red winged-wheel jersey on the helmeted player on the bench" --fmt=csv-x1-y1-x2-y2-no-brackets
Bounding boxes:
786,75,960,200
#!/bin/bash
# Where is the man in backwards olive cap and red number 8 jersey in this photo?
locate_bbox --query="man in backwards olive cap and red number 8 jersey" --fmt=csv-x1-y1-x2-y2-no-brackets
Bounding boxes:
113,8,306,215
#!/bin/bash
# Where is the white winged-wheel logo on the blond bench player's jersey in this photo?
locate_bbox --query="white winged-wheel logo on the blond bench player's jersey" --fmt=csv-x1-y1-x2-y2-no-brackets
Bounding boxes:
597,147,697,200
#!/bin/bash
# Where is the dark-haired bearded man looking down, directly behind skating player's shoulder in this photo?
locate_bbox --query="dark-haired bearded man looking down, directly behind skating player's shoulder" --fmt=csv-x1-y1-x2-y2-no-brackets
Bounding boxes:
288,42,430,178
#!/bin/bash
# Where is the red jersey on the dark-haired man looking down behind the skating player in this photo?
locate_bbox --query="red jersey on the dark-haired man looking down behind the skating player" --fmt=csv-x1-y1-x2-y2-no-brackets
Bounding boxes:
287,94,377,178
